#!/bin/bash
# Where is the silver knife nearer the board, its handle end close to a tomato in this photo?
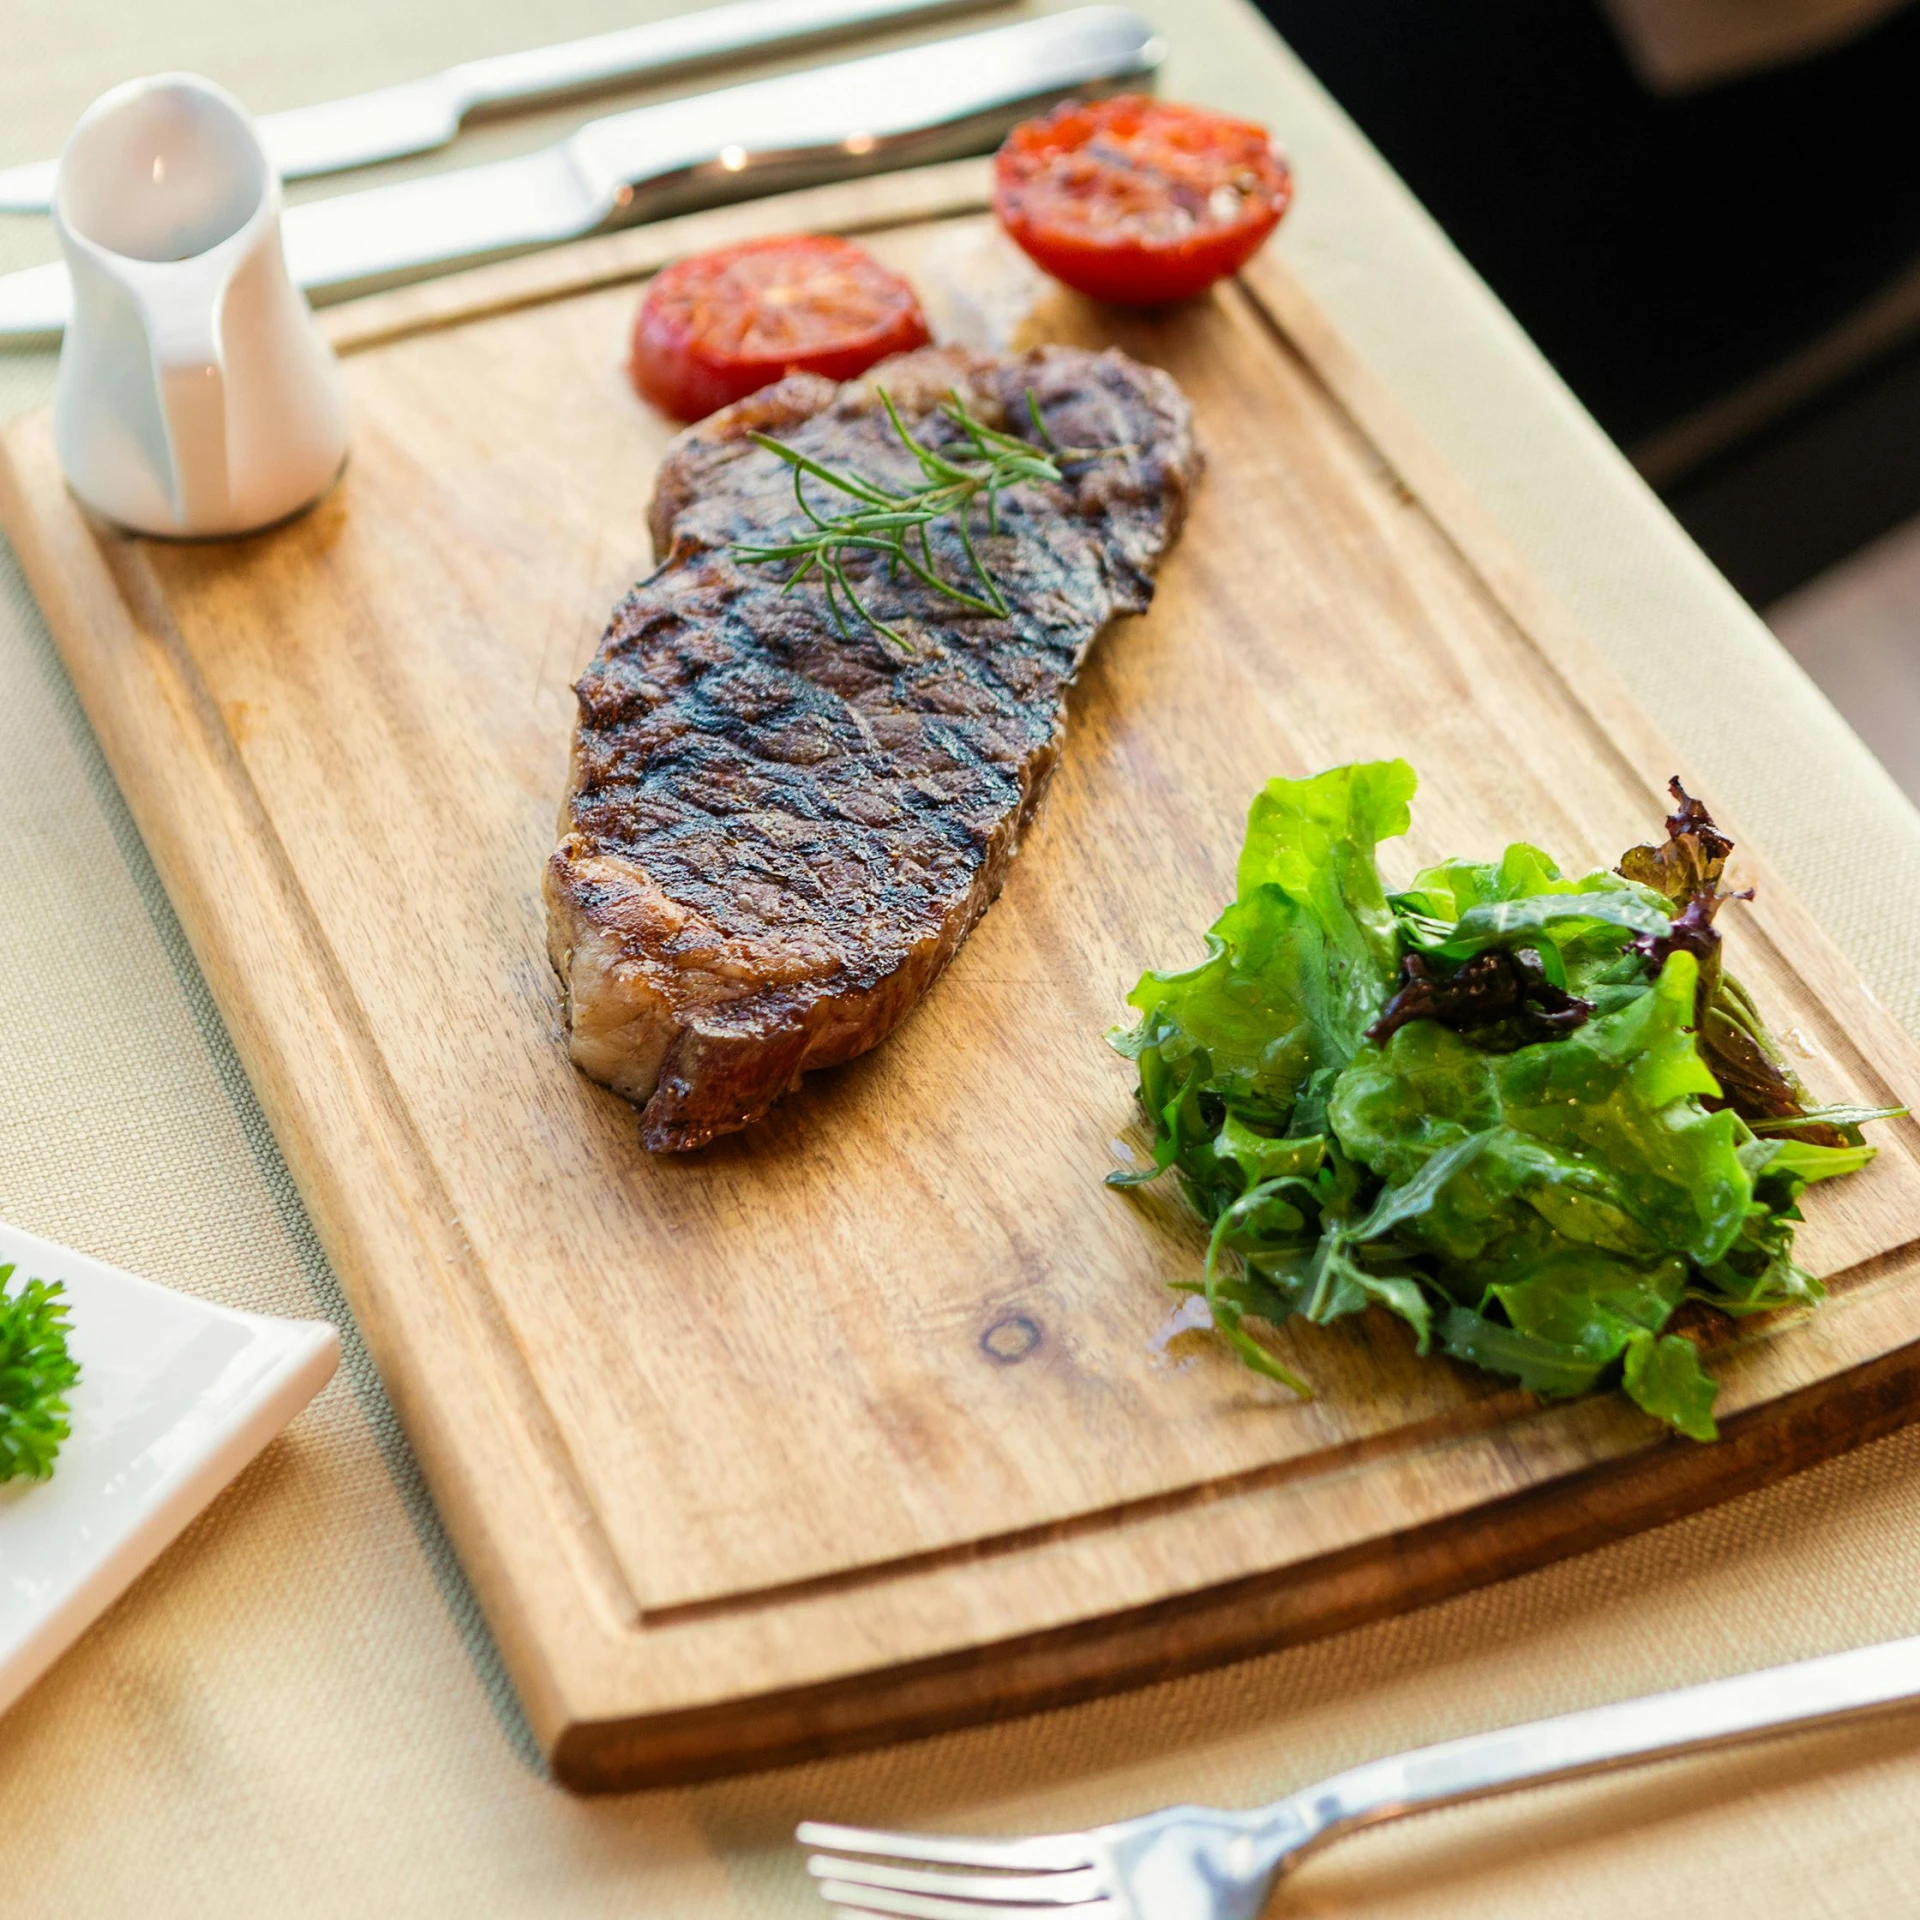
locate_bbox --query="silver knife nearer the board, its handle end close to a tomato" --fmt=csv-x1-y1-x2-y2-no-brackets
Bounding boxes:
0,6,1165,340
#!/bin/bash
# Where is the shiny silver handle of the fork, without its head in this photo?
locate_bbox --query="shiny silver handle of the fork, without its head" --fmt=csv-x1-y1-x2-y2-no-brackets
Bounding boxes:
1290,1638,1920,1845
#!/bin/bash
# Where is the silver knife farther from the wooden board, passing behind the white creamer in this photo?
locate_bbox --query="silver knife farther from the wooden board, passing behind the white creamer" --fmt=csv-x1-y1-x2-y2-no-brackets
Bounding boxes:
0,0,993,213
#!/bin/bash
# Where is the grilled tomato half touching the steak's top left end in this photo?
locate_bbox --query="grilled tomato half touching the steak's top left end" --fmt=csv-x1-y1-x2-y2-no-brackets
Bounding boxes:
630,234,931,420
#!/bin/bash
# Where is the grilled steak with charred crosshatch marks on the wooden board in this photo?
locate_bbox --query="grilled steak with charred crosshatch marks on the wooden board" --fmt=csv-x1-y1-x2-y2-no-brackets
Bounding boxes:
547,348,1198,1152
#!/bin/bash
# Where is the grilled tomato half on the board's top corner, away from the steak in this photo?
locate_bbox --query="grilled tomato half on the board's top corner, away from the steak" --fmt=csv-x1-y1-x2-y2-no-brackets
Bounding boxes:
993,94,1292,307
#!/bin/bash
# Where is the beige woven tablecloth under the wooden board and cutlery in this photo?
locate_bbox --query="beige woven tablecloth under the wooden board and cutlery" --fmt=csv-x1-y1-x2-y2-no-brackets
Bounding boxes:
0,0,1920,1920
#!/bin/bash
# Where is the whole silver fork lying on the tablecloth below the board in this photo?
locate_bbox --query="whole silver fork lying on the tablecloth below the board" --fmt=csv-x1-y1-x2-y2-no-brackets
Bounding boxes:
795,1638,1920,1920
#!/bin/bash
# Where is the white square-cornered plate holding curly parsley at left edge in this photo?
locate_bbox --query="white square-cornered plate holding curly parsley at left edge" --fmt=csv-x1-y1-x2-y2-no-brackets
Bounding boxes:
0,1221,340,1713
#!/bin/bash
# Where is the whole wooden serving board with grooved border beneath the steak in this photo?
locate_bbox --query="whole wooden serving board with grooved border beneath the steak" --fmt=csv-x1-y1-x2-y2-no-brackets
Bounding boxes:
0,163,1920,1788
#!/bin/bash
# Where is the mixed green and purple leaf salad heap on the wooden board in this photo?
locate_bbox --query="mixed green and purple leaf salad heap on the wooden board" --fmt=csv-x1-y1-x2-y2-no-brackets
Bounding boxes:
1110,760,1903,1440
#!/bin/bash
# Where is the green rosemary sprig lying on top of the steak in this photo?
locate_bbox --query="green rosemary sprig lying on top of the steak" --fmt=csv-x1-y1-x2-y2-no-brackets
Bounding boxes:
733,388,1119,659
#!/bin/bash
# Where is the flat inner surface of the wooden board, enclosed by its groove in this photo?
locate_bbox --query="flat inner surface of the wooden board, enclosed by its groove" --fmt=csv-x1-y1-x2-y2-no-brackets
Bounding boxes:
139,234,1920,1609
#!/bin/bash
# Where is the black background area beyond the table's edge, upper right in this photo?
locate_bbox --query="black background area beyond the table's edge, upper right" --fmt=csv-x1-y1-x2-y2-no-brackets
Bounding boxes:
1260,0,1920,605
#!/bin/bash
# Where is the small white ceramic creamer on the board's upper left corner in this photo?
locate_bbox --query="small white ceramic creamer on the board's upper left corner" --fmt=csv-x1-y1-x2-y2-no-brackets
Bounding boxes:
54,73,348,536
